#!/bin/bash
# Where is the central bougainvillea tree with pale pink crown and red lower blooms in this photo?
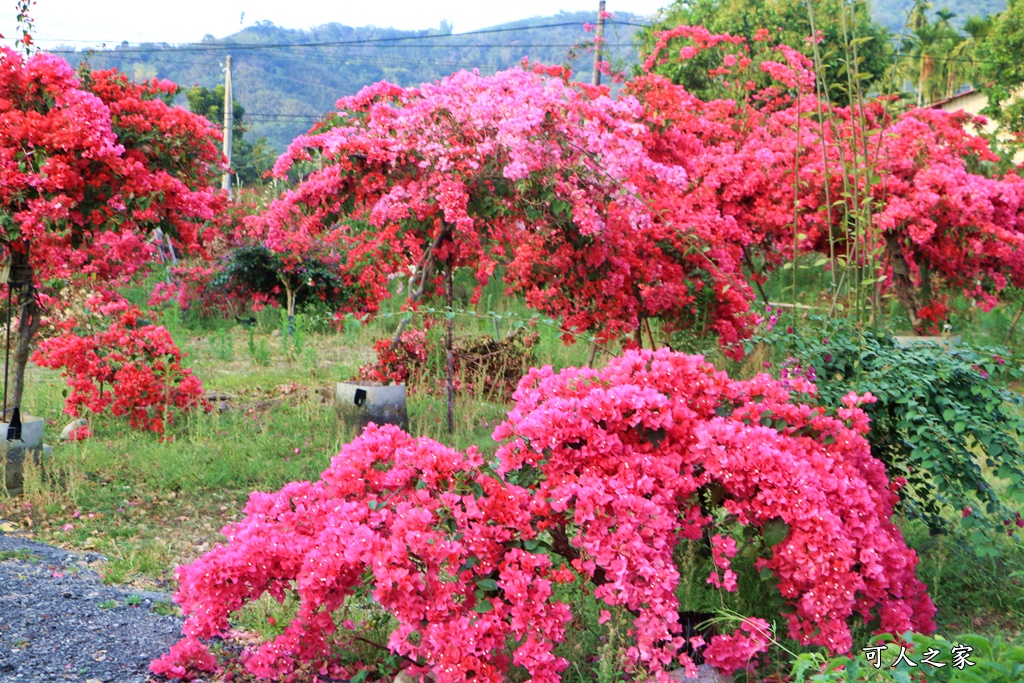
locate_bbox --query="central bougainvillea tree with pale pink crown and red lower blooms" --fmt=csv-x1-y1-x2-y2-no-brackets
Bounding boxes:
254,62,749,352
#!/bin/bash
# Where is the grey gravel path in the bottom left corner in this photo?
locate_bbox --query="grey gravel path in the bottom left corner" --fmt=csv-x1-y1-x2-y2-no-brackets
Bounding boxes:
0,533,181,683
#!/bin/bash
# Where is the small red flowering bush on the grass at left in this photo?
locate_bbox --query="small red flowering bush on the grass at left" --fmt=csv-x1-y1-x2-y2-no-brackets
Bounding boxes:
32,301,207,434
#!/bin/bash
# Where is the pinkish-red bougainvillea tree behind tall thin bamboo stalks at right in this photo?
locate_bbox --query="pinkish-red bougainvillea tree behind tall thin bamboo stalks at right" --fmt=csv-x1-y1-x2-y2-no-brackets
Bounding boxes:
629,27,1024,328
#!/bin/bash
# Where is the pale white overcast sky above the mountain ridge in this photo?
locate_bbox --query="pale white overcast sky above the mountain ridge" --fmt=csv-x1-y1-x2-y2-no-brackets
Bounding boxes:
0,0,671,47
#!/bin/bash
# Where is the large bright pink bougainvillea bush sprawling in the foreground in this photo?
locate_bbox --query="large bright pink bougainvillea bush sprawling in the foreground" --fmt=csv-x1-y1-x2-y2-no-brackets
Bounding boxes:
153,349,934,683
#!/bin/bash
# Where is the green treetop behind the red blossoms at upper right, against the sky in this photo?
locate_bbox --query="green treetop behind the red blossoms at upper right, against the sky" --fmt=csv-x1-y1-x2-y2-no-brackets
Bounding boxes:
637,0,893,104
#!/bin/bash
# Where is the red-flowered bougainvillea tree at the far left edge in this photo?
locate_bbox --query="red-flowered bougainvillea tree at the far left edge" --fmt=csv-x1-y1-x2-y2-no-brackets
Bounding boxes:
0,49,220,405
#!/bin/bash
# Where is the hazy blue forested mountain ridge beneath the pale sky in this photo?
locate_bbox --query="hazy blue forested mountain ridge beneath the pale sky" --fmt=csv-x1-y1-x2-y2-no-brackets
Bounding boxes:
54,12,642,152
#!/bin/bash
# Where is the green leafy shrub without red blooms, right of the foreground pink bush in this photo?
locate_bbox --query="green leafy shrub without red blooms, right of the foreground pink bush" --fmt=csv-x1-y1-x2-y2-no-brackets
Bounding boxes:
751,318,1024,530
